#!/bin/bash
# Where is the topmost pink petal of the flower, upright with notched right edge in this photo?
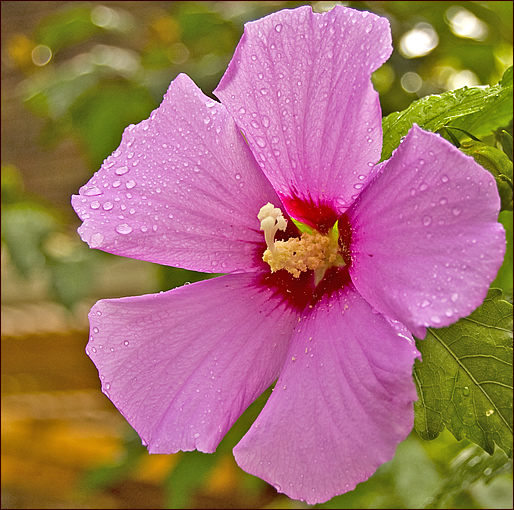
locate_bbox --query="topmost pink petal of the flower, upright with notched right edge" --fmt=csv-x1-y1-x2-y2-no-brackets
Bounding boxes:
215,6,392,217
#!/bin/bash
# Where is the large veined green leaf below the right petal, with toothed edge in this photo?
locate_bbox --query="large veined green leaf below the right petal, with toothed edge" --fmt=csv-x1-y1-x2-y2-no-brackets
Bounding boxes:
414,289,512,456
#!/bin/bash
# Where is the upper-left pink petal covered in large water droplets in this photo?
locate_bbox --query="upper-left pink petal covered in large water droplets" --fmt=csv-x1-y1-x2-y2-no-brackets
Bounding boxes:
72,75,279,272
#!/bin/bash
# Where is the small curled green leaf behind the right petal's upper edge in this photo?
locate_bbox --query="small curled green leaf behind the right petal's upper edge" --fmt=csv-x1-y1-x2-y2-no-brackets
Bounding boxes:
460,141,512,211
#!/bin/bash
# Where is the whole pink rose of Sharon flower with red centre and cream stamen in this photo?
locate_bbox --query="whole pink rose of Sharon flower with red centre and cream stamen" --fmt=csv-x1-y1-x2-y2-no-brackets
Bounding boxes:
72,6,505,503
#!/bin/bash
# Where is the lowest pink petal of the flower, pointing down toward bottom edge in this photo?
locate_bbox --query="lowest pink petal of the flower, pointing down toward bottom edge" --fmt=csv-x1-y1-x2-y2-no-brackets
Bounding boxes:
234,284,418,504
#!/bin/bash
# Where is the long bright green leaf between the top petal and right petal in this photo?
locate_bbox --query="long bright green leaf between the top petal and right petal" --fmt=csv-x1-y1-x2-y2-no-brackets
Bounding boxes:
381,68,512,160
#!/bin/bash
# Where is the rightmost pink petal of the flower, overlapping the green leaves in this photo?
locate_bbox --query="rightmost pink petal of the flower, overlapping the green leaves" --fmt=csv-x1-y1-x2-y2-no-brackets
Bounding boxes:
348,125,505,338
